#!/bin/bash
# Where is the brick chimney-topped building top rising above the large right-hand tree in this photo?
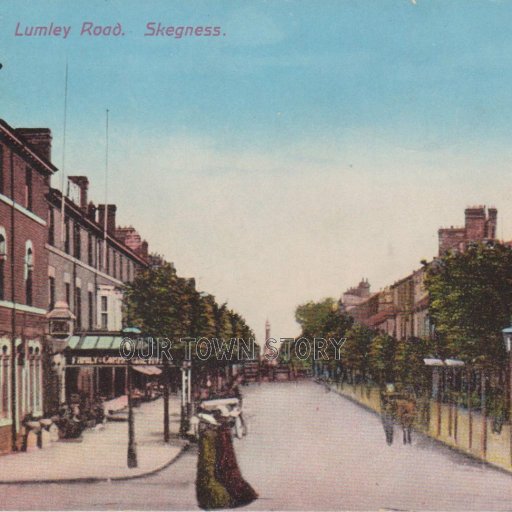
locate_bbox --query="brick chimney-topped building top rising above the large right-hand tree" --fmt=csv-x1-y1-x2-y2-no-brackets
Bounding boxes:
438,206,498,256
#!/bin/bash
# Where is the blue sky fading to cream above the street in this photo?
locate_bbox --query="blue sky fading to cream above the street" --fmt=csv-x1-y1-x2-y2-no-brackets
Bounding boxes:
0,0,512,341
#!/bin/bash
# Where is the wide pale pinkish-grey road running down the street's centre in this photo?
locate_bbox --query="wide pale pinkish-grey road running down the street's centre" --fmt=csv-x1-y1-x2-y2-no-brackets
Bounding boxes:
0,382,512,510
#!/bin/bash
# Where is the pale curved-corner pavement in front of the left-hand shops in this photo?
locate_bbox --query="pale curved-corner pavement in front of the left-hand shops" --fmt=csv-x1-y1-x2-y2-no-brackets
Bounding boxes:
0,396,187,482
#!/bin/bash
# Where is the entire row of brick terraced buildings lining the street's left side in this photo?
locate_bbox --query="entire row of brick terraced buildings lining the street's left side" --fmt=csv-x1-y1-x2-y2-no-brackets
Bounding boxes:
0,120,149,453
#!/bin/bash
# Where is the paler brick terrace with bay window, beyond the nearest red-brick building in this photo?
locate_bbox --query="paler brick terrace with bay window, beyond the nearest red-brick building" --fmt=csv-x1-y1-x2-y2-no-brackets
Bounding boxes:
46,176,148,411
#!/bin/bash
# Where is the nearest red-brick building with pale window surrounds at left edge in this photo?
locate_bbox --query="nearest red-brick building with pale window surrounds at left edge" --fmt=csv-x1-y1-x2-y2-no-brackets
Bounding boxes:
0,120,57,452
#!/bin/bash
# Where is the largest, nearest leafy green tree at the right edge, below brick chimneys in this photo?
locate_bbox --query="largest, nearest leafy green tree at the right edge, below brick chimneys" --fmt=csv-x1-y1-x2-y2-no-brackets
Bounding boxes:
425,243,512,365
